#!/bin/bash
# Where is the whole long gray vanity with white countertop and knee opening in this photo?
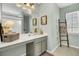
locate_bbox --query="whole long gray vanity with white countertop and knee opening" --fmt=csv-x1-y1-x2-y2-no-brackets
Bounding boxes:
0,34,47,56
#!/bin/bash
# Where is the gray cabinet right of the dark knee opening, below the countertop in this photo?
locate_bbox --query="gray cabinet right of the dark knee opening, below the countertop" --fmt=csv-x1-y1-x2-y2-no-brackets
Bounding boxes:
34,37,47,56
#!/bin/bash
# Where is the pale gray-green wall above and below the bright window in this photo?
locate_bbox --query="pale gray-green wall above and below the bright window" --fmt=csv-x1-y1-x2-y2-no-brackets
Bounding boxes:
60,3,79,47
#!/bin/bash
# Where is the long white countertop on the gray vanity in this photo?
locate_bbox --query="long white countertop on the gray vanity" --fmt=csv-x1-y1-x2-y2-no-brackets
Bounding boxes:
0,34,47,48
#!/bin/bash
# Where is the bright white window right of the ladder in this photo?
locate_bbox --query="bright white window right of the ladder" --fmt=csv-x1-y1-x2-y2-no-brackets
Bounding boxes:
66,11,79,33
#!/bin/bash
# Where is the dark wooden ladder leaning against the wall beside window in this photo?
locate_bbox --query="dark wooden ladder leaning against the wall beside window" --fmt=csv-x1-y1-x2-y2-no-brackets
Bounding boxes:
58,19,69,47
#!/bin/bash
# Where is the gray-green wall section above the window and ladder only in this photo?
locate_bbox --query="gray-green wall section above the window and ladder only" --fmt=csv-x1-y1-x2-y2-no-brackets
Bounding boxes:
60,3,79,20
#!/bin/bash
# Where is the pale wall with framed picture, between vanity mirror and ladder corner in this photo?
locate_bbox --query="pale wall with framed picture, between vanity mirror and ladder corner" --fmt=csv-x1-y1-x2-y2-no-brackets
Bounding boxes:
31,3,59,51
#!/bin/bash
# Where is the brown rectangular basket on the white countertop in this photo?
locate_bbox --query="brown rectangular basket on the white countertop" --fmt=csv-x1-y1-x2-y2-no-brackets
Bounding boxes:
3,33,19,42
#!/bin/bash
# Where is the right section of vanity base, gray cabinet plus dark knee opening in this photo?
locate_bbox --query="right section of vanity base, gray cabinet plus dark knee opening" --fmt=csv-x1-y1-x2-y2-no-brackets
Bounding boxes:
26,36,47,56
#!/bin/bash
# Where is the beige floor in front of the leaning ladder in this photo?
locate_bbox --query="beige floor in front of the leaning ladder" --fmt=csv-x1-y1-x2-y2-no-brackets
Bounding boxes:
52,46,79,56
